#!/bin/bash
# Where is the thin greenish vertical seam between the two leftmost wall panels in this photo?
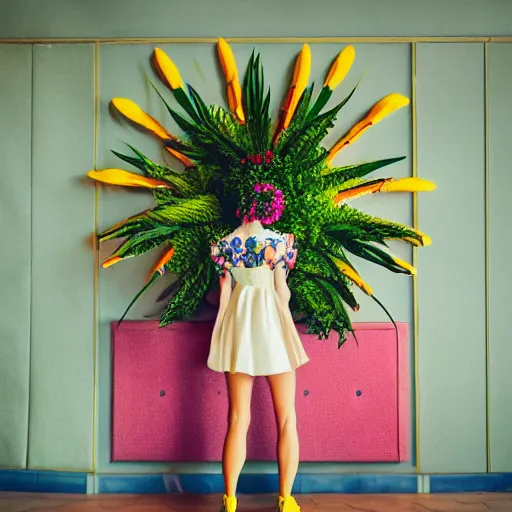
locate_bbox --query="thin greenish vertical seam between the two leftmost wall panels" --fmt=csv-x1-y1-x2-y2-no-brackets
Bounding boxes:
25,44,34,468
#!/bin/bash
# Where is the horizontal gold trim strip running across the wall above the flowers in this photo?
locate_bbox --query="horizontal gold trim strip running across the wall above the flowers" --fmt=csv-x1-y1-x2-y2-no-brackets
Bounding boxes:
0,36,512,44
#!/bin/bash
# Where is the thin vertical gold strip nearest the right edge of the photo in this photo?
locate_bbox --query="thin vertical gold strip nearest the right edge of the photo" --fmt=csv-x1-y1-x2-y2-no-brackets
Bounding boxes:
484,43,492,473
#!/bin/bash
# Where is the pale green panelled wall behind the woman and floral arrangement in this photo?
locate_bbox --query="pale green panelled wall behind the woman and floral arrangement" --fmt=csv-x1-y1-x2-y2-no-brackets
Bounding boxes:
0,0,512,472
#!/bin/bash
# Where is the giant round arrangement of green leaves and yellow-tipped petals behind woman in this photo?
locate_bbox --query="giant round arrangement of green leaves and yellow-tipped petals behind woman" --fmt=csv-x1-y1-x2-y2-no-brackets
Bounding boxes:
88,39,435,346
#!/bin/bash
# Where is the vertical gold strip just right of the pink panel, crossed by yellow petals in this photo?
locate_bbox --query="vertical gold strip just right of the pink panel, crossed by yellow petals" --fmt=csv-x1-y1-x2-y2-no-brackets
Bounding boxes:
411,43,421,473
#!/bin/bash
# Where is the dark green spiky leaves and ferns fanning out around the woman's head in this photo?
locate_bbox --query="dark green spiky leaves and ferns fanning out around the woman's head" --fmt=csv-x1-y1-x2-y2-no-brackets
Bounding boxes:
99,47,421,346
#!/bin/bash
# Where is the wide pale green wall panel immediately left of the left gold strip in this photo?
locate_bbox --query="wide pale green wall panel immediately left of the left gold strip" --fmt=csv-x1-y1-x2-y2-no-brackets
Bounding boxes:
29,44,94,469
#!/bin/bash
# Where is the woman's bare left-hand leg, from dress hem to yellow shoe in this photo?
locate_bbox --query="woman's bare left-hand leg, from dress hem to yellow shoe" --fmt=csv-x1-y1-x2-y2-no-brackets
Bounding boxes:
222,373,253,496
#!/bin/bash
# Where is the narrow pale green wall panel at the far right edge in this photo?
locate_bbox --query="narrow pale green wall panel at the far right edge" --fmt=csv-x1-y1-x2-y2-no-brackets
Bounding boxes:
487,43,512,472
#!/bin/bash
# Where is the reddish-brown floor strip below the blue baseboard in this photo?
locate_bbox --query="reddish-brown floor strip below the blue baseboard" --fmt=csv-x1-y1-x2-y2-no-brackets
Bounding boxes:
0,493,512,512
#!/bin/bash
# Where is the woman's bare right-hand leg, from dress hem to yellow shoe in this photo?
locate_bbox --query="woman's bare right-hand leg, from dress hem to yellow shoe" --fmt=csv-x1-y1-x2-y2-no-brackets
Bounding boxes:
267,372,299,498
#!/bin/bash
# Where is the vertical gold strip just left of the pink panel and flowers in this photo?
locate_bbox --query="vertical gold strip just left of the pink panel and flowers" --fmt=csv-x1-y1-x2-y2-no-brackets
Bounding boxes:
92,43,100,472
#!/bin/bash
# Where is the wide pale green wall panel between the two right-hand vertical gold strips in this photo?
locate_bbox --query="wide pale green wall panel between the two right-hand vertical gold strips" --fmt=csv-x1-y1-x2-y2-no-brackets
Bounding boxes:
417,43,487,472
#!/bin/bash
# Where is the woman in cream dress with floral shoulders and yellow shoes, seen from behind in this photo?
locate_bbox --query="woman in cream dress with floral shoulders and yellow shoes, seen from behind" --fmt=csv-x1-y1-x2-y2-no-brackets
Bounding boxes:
208,184,308,512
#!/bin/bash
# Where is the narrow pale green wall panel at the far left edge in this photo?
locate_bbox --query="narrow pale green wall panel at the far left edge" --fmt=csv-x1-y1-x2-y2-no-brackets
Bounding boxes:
0,45,32,468
